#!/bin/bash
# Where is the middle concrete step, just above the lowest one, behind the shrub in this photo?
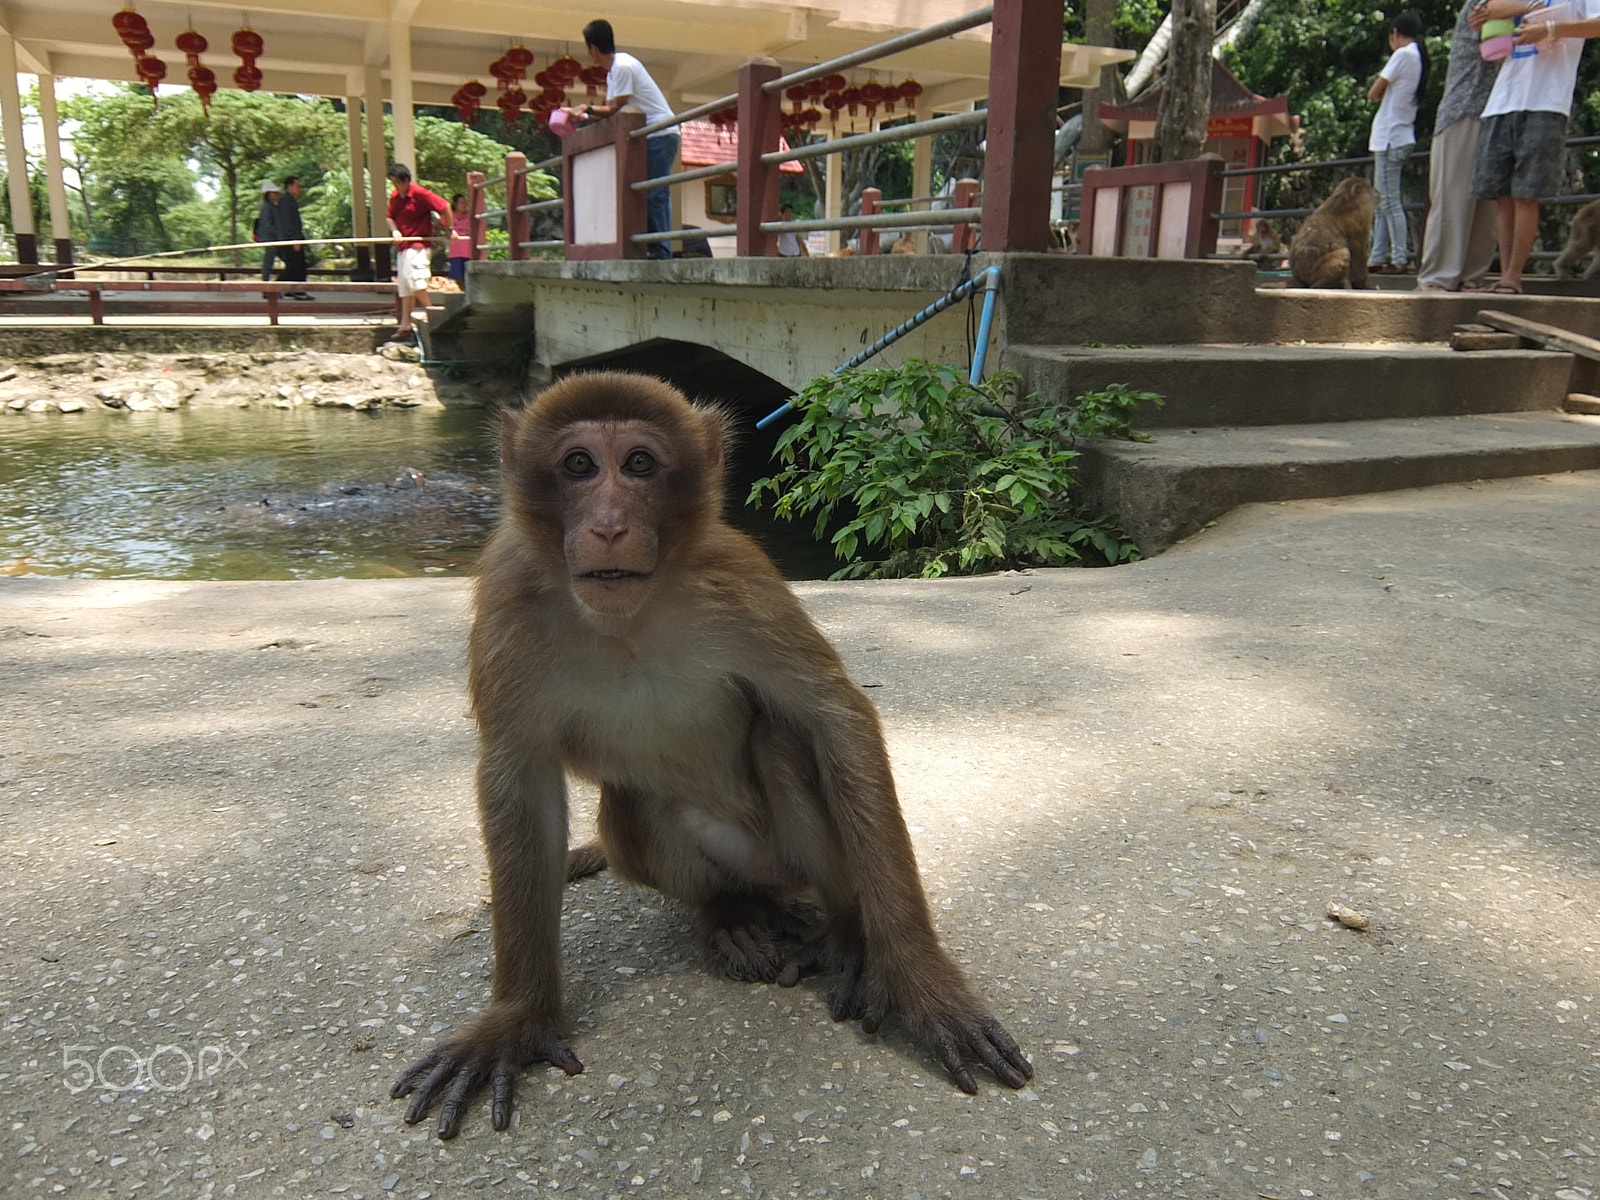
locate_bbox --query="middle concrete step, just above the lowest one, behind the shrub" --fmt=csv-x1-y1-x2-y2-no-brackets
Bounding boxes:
1005,344,1590,429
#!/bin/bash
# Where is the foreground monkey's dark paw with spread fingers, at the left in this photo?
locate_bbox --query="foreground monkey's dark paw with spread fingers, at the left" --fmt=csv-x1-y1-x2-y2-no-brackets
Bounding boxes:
389,1008,584,1139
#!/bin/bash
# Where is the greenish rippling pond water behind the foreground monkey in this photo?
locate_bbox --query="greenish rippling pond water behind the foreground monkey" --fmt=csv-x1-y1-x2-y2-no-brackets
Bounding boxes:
0,408,832,579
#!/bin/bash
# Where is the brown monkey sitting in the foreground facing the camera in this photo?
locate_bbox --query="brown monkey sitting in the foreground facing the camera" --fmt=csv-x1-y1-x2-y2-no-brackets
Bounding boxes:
390,374,1034,1138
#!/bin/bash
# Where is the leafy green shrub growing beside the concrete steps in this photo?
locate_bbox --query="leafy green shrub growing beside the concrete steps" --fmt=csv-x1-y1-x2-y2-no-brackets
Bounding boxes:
749,358,1162,579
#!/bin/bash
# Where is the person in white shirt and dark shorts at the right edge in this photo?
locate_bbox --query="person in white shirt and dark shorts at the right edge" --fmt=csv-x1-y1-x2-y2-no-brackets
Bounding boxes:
1470,0,1600,294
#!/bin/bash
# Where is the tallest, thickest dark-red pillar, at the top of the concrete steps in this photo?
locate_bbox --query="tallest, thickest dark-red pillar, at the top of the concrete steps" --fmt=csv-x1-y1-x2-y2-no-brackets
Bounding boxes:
982,0,1064,253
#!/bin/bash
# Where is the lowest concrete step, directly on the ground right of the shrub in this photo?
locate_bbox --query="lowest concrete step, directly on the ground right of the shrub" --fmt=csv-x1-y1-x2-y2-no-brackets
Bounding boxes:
1082,409,1600,554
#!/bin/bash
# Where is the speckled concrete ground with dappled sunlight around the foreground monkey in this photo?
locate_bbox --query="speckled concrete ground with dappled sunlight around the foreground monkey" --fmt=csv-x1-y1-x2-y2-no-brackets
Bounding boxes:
0,474,1600,1200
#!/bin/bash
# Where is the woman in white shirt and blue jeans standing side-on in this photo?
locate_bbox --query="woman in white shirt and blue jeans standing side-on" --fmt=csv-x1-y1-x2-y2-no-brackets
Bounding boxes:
1366,10,1427,275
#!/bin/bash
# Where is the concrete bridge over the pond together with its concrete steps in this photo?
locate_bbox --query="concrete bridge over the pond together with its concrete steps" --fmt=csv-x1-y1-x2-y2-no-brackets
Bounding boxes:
432,254,1600,552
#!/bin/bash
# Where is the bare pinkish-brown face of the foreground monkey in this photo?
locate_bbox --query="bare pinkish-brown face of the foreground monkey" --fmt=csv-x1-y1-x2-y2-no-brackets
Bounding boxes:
549,421,683,624
